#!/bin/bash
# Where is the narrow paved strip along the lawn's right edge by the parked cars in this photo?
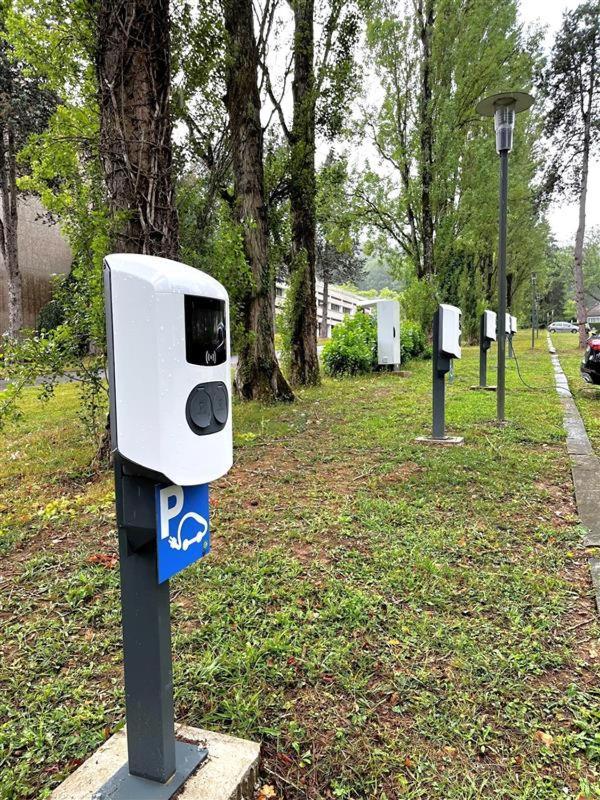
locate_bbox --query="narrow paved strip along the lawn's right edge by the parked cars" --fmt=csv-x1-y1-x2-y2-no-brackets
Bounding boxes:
548,336,600,612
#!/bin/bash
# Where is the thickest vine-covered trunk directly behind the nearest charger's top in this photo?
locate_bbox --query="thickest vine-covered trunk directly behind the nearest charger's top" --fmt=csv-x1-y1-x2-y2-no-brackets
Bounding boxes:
96,0,178,258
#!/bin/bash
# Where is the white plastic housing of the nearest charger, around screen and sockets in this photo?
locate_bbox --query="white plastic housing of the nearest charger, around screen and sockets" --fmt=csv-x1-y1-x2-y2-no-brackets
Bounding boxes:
104,254,233,486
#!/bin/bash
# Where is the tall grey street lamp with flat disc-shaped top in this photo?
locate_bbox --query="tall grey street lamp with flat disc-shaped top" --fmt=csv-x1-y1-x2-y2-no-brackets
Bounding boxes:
477,92,533,423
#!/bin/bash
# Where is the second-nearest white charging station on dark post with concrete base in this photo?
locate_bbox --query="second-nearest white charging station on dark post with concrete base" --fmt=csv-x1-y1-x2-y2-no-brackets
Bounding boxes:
417,303,464,445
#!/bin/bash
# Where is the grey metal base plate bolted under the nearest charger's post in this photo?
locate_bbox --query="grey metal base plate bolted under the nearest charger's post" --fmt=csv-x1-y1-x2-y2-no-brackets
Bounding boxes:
92,741,208,800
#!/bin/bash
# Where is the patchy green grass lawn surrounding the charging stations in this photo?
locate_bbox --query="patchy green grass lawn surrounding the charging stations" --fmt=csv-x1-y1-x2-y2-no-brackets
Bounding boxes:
0,332,600,800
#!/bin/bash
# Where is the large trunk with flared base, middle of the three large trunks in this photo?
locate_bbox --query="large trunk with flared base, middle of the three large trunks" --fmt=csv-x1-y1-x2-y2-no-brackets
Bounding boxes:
223,0,294,400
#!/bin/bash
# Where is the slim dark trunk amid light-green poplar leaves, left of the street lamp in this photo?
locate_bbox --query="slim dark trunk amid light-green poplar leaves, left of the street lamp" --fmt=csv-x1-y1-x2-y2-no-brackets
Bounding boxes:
417,0,435,277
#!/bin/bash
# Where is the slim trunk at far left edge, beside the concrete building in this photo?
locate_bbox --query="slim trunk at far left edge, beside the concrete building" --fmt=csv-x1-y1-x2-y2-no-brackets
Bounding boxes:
0,122,23,337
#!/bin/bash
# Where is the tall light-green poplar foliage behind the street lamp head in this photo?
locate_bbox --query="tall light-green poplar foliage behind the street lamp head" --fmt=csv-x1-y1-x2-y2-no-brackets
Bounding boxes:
356,0,548,318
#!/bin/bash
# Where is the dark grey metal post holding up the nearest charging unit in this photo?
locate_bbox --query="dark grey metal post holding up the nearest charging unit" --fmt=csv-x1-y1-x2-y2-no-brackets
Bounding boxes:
115,458,176,783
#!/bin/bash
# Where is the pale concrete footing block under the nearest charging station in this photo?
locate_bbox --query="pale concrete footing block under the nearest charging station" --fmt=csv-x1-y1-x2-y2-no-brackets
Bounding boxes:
51,725,260,800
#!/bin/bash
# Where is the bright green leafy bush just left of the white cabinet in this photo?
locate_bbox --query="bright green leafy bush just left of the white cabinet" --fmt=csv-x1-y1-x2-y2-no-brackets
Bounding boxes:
323,313,377,377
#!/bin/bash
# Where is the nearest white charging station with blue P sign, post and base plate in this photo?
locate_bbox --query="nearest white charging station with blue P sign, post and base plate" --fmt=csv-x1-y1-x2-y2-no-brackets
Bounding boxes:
101,254,233,800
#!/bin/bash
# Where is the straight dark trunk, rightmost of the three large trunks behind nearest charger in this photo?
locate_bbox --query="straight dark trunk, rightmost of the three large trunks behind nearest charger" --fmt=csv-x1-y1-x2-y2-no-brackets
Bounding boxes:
288,0,319,386
